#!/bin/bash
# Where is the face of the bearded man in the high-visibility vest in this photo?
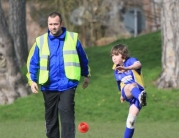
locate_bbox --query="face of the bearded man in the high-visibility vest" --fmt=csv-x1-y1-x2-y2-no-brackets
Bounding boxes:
48,16,62,36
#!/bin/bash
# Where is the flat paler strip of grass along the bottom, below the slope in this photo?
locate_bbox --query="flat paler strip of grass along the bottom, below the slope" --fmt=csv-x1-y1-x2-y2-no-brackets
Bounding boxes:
0,121,179,138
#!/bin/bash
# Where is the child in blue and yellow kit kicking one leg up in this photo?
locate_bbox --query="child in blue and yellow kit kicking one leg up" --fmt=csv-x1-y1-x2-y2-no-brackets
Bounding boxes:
110,44,147,138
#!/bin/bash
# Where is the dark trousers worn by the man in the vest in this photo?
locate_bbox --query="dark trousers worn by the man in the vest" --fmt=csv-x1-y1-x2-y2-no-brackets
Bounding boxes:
43,88,76,138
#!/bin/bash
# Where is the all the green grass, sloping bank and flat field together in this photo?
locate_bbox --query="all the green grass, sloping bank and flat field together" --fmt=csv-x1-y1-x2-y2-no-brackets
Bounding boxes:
0,32,179,138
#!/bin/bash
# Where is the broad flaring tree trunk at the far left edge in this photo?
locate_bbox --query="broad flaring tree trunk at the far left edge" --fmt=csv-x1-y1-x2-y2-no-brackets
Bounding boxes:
0,1,30,104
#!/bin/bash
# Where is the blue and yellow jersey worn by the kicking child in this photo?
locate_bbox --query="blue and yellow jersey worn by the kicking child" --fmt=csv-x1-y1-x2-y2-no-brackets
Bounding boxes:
113,57,144,91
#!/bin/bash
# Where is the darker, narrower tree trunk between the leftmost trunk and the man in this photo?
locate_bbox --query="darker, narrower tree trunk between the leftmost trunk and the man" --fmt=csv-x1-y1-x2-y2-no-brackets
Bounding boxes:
9,0,28,67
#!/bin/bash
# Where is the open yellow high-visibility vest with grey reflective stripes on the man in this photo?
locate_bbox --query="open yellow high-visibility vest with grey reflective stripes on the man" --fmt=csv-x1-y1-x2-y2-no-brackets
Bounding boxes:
36,31,81,84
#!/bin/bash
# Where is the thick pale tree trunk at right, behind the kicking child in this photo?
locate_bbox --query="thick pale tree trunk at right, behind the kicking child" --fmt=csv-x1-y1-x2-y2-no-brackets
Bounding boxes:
157,0,179,88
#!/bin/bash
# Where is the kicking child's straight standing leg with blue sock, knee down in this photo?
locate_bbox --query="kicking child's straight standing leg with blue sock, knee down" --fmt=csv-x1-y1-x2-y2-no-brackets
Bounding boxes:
124,104,139,138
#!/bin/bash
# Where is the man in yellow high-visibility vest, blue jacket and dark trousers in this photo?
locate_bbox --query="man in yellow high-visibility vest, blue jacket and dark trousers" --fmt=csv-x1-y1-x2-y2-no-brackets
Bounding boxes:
27,12,90,138
